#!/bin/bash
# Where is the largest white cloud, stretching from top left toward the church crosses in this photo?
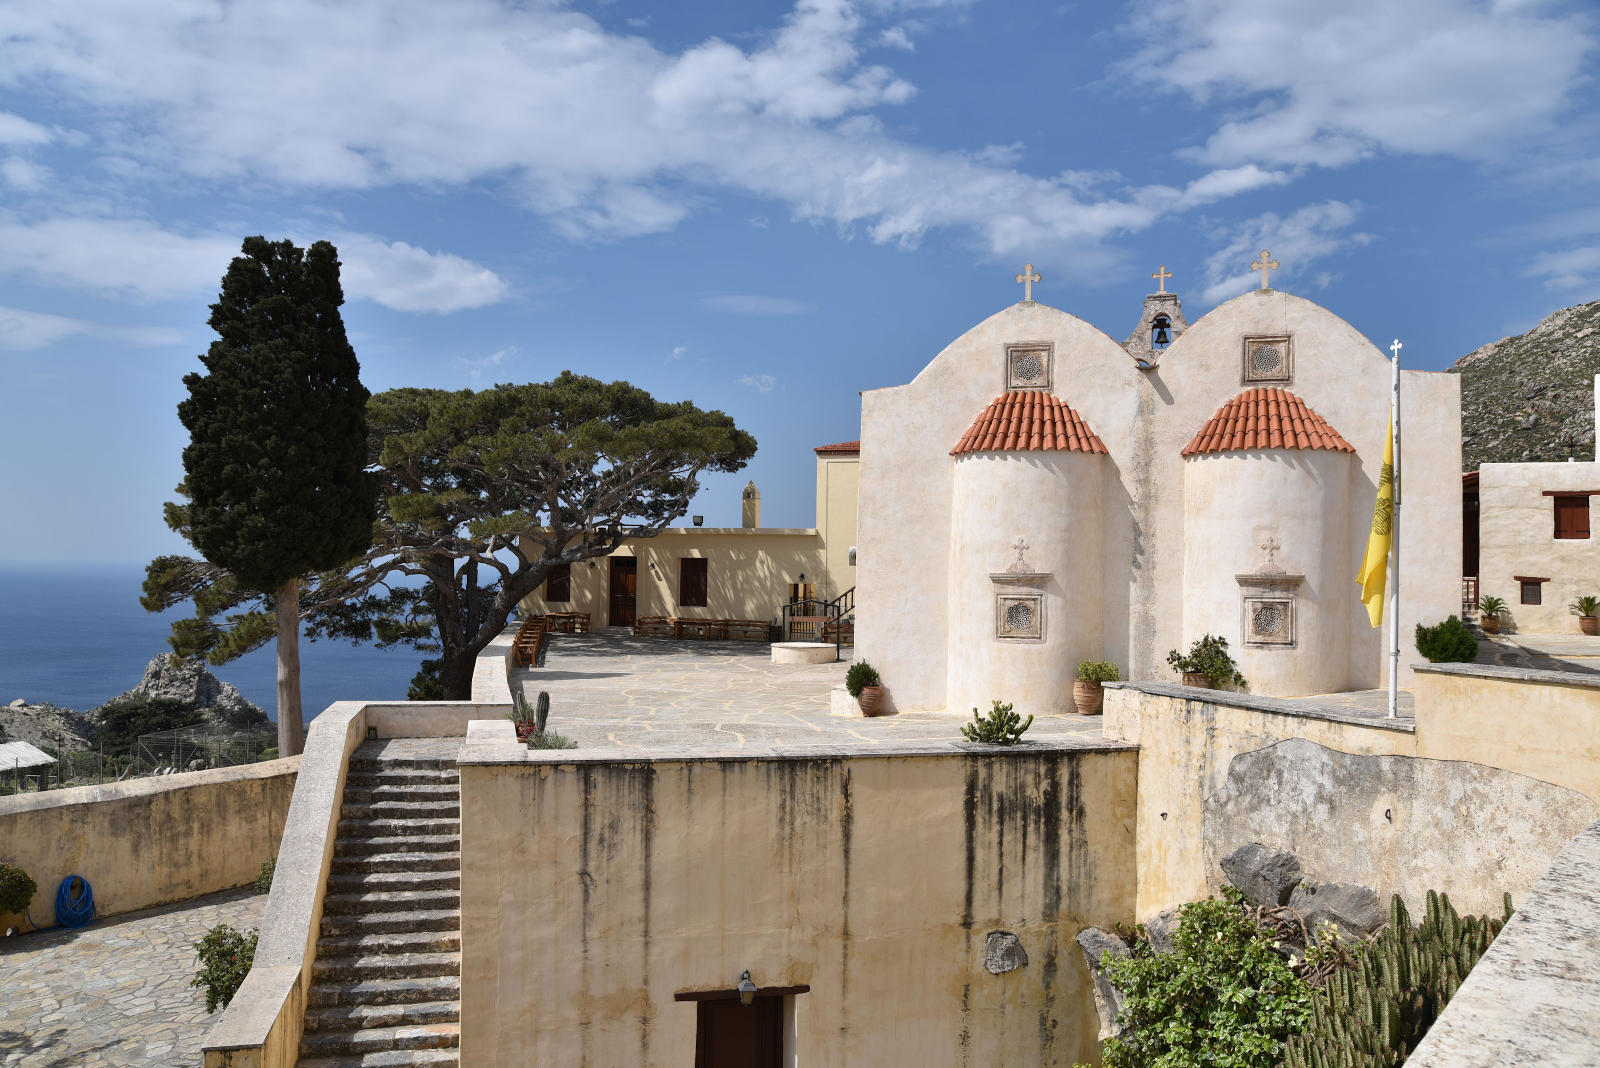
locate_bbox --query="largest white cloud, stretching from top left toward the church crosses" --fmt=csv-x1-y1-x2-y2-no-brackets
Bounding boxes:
0,0,1275,271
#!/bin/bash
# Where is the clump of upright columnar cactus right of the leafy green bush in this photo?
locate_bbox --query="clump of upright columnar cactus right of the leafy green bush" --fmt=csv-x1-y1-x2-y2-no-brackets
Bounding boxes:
1283,891,1512,1068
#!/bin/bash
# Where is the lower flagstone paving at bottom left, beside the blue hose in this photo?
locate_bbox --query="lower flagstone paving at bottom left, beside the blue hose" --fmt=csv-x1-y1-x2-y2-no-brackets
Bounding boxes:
0,887,267,1068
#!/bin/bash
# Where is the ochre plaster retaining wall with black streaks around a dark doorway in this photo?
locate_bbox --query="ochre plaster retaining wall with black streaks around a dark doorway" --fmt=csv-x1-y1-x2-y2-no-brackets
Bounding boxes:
461,747,1136,1066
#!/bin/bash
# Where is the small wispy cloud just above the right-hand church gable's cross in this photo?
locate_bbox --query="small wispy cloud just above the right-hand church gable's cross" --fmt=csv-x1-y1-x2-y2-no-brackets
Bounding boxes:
1200,200,1373,302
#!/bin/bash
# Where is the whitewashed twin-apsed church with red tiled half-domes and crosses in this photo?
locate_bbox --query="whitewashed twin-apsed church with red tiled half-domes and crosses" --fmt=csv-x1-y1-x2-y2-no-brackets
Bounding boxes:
856,253,1461,713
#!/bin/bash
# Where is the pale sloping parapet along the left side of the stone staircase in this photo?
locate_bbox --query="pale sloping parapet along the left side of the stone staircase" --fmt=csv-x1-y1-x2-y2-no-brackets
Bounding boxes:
205,700,506,1068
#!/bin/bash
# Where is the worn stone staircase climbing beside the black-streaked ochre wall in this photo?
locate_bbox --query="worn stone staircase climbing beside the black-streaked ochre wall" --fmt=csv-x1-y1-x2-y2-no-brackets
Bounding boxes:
299,739,461,1068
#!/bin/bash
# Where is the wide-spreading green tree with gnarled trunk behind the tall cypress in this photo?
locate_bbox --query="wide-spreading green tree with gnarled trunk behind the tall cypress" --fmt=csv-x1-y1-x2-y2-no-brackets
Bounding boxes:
152,371,755,700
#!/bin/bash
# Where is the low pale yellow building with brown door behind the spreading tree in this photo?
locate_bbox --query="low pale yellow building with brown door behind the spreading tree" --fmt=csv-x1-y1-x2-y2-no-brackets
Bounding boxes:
522,441,861,628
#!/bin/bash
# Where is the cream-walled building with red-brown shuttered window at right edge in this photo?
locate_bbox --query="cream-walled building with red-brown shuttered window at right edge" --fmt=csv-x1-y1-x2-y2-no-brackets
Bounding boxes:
1478,460,1600,635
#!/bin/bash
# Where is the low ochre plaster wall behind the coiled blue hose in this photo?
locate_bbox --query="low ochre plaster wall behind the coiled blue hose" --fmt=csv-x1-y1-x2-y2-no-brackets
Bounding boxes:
0,756,301,929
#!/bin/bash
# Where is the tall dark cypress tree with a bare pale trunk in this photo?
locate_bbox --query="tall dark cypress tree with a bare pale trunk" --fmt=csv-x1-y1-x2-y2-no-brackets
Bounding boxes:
178,237,378,756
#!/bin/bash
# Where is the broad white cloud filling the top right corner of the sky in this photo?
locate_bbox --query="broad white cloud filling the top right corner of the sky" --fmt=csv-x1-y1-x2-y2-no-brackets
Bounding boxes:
1123,0,1595,166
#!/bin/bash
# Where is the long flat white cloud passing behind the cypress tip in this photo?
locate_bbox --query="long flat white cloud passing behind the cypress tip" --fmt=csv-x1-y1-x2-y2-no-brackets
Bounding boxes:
0,216,509,312
